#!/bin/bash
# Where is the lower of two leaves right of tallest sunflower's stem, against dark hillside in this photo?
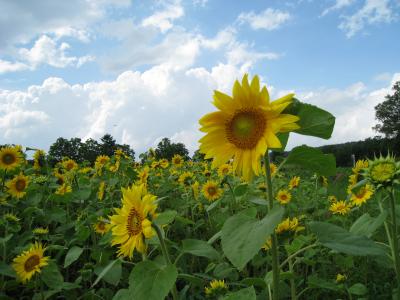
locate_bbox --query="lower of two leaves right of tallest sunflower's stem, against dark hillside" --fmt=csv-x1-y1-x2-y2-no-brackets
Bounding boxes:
284,145,336,176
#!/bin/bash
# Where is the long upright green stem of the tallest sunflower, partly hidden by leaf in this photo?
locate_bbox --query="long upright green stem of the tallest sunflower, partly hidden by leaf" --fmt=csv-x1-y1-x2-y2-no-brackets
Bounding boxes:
264,151,279,300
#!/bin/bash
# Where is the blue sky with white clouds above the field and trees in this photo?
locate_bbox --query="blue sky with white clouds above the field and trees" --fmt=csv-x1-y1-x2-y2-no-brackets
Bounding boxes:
0,0,400,153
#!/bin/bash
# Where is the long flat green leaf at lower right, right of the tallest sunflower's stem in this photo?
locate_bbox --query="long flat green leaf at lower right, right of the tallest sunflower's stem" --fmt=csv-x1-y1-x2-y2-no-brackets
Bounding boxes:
309,222,385,256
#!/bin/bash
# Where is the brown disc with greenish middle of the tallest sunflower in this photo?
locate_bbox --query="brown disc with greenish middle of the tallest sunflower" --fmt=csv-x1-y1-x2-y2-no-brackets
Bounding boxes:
225,109,266,149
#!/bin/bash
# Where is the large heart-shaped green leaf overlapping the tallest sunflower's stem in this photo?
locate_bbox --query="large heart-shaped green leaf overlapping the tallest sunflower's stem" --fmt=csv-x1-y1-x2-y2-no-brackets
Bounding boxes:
221,206,284,270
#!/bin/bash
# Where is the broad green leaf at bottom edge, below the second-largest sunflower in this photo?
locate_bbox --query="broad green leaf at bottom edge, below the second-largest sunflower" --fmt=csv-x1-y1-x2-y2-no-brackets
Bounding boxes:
129,260,178,300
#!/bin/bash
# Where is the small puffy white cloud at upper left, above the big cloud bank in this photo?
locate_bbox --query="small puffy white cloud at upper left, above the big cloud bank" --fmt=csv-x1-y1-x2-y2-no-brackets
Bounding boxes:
19,35,93,69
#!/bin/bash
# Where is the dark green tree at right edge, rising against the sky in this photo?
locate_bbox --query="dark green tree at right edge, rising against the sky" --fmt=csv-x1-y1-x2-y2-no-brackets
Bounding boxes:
374,81,400,139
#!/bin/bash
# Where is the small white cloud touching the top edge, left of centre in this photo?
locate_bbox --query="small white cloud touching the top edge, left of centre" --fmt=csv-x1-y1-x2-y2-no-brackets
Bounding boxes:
142,0,185,32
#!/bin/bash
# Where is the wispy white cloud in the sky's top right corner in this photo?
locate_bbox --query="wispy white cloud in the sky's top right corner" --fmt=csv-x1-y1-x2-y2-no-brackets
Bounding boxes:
339,0,394,38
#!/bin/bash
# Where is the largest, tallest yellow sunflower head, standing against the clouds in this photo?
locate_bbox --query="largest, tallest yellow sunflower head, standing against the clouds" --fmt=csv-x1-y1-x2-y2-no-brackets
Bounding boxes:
199,74,299,180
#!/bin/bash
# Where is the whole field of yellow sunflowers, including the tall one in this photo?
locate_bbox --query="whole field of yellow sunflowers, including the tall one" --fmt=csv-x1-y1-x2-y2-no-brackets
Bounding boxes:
0,75,400,300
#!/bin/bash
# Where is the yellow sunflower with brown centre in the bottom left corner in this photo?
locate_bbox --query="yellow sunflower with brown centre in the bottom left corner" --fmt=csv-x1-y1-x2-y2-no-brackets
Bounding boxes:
13,242,50,283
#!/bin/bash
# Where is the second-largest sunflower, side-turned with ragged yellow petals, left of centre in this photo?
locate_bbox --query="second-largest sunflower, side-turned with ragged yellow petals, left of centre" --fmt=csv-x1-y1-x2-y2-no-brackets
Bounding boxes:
110,184,157,258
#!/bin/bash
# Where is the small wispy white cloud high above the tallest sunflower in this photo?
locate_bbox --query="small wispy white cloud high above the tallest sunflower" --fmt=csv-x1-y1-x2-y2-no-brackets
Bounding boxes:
238,8,291,30
